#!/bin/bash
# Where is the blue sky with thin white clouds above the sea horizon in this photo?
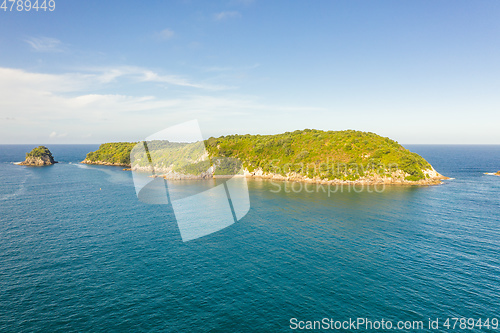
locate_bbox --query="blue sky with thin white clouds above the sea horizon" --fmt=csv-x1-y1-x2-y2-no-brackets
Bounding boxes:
0,0,500,144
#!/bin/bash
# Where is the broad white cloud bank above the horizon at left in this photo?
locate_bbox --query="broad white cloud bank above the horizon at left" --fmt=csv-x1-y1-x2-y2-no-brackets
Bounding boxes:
0,67,320,143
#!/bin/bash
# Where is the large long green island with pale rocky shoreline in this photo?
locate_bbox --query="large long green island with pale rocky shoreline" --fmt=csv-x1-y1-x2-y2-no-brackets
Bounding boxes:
82,129,448,185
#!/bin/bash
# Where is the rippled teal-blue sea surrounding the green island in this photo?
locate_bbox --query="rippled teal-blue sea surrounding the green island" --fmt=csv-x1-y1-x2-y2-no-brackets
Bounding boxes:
0,145,500,332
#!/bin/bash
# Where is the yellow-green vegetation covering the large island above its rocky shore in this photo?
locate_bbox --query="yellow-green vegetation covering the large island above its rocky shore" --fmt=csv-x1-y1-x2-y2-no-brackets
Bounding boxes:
82,130,431,180
